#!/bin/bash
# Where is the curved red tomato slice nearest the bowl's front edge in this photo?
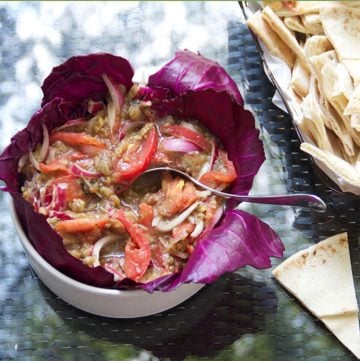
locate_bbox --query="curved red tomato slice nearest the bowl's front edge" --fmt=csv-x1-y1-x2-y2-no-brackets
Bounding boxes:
116,210,151,282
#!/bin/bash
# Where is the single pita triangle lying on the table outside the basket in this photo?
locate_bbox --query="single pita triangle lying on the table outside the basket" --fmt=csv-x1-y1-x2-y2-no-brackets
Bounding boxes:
273,233,360,358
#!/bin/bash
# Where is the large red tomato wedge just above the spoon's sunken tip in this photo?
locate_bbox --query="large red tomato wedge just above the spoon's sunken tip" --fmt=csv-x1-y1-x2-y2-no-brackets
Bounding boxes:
113,128,158,183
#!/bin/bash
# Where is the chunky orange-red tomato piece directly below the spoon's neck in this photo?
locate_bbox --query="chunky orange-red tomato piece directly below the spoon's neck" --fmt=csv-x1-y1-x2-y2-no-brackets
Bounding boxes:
161,174,199,217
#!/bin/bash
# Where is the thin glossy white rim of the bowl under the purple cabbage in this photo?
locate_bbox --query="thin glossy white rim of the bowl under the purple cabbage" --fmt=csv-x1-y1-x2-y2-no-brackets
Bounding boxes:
9,196,170,297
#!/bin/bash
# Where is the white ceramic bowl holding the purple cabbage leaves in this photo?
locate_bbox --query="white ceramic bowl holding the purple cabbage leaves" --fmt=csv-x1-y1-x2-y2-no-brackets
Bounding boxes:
10,199,204,318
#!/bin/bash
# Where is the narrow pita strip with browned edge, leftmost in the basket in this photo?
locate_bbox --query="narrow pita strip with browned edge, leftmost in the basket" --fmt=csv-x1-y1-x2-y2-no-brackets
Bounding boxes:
247,11,295,68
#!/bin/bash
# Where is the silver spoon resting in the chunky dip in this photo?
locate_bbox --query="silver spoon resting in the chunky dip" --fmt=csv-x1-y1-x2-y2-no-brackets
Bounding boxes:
140,167,326,212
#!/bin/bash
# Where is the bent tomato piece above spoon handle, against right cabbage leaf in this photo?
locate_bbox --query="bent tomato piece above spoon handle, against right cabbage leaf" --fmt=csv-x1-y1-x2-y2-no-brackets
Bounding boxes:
200,151,237,186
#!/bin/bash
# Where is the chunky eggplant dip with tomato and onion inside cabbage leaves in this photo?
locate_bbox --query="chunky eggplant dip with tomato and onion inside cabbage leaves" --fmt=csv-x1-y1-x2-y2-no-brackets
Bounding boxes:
19,80,236,283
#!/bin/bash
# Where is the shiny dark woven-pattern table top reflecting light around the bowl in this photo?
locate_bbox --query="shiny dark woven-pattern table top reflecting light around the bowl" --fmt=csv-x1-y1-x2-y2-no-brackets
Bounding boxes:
0,1,360,361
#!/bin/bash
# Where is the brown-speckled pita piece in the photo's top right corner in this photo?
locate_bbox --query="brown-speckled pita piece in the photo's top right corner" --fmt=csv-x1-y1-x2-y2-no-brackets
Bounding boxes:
320,5,360,60
